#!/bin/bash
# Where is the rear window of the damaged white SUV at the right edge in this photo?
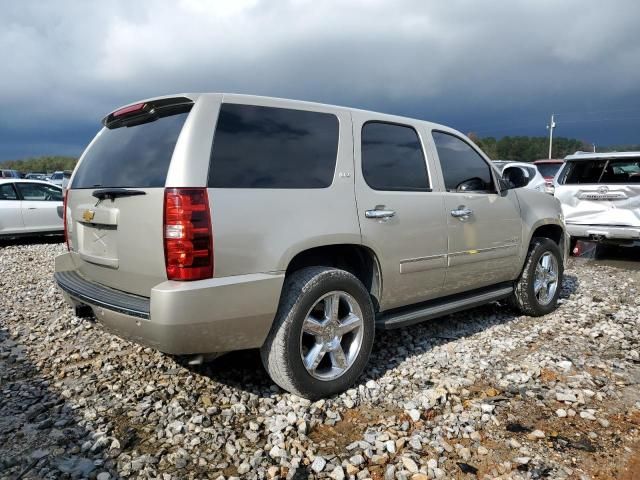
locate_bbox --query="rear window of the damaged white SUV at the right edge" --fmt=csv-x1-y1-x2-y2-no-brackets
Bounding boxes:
559,158,640,185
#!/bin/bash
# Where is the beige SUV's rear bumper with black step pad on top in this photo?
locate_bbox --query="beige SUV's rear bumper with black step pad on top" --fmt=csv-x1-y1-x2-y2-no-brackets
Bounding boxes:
55,253,284,355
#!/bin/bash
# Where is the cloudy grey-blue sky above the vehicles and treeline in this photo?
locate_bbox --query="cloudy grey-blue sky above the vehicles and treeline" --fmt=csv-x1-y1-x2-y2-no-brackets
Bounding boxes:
0,0,640,161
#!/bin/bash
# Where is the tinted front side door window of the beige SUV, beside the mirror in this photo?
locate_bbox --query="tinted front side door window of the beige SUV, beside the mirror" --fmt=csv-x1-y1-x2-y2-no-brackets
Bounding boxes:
433,132,495,192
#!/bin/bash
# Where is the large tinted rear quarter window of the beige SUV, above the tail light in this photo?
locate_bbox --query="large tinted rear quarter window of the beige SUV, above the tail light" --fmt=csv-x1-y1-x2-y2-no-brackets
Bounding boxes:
209,103,338,188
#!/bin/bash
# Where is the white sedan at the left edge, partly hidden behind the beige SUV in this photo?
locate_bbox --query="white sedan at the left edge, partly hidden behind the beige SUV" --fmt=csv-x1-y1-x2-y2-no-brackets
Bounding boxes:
0,178,64,238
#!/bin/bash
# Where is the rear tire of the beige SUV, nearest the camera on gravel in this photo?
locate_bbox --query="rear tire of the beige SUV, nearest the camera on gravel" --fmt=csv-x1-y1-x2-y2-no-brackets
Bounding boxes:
260,267,375,400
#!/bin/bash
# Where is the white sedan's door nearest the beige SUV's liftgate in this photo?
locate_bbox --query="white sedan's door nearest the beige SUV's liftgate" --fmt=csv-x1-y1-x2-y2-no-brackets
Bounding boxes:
15,182,64,232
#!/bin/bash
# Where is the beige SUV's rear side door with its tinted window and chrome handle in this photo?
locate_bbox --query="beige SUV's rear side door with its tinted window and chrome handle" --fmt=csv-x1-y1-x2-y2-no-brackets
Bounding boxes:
353,113,447,310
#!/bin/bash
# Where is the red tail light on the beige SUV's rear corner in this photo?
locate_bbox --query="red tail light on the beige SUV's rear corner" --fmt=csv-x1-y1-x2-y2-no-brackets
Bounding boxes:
164,188,213,280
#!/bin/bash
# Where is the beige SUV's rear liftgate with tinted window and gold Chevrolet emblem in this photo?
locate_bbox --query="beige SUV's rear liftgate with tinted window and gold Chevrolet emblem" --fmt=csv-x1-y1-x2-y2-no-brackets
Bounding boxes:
67,97,198,296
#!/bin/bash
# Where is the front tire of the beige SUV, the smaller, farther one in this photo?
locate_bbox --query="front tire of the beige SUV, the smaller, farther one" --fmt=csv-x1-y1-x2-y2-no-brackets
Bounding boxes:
509,238,564,317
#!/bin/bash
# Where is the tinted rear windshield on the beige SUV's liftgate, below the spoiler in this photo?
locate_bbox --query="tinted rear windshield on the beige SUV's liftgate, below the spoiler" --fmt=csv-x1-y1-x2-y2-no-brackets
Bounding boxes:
73,110,189,188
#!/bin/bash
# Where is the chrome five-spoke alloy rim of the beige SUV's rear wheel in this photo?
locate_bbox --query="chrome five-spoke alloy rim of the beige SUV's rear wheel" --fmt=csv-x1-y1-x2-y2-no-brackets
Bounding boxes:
300,291,364,381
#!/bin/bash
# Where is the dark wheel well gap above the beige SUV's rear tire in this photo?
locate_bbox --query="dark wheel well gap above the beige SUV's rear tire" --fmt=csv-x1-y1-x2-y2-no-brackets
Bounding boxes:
286,244,382,311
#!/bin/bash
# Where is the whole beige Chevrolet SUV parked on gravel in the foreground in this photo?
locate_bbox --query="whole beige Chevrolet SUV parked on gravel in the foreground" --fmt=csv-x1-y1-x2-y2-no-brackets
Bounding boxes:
55,94,568,398
